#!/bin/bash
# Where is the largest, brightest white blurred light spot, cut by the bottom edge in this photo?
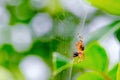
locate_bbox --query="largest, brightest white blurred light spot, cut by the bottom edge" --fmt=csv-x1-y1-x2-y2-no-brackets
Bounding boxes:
20,55,50,80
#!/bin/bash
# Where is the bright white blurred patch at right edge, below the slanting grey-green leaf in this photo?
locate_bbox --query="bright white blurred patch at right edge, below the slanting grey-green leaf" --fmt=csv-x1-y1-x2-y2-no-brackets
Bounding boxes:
100,35,120,68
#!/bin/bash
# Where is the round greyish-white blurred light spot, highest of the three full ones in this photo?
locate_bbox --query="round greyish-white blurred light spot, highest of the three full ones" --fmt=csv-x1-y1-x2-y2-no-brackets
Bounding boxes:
31,13,53,36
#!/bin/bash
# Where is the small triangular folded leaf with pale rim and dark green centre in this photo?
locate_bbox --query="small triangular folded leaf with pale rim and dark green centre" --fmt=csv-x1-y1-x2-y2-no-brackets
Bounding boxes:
53,52,70,75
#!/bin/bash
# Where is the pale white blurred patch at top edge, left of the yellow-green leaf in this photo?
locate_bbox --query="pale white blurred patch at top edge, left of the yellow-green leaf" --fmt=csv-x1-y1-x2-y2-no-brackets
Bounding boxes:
60,0,96,18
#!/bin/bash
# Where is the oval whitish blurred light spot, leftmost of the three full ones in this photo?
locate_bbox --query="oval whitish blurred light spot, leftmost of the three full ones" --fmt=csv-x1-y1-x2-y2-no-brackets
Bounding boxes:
11,24,32,52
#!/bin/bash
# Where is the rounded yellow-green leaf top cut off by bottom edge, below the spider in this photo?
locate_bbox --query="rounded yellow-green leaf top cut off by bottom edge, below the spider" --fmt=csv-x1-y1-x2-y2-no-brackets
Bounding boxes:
77,72,105,80
